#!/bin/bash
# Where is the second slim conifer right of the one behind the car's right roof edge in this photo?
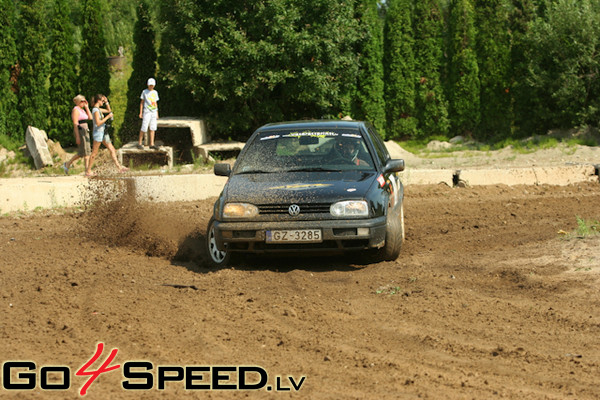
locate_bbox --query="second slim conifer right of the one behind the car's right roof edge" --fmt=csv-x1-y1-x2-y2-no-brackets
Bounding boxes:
413,0,449,137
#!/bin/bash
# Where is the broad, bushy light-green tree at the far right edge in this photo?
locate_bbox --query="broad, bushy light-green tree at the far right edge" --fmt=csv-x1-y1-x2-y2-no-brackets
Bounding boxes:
527,0,600,129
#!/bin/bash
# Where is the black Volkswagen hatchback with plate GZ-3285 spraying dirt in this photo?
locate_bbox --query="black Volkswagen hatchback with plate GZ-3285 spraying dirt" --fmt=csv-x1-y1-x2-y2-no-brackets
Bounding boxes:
206,120,404,266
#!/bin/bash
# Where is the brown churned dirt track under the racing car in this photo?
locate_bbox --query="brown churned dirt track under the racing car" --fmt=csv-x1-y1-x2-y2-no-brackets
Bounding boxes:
0,184,600,399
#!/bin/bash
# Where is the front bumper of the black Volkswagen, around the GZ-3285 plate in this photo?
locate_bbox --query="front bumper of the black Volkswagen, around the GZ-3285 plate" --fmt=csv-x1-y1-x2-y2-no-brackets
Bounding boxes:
214,216,386,253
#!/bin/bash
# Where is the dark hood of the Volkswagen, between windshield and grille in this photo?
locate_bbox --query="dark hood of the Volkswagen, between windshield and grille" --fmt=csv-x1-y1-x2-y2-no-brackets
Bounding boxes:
223,171,377,204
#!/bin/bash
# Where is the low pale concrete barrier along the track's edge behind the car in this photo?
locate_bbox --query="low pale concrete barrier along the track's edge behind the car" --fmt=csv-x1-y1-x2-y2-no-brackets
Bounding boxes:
0,165,599,214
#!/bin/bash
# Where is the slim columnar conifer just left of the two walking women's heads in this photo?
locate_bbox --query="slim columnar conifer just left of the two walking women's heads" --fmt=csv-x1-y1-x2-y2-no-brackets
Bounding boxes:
48,0,78,145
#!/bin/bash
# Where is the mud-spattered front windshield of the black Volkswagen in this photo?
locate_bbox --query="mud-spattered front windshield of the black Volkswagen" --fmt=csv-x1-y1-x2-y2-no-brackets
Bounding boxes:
233,129,374,174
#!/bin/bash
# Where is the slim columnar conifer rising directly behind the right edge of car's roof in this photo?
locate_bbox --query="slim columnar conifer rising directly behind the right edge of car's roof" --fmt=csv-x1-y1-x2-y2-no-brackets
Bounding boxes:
354,0,386,137
